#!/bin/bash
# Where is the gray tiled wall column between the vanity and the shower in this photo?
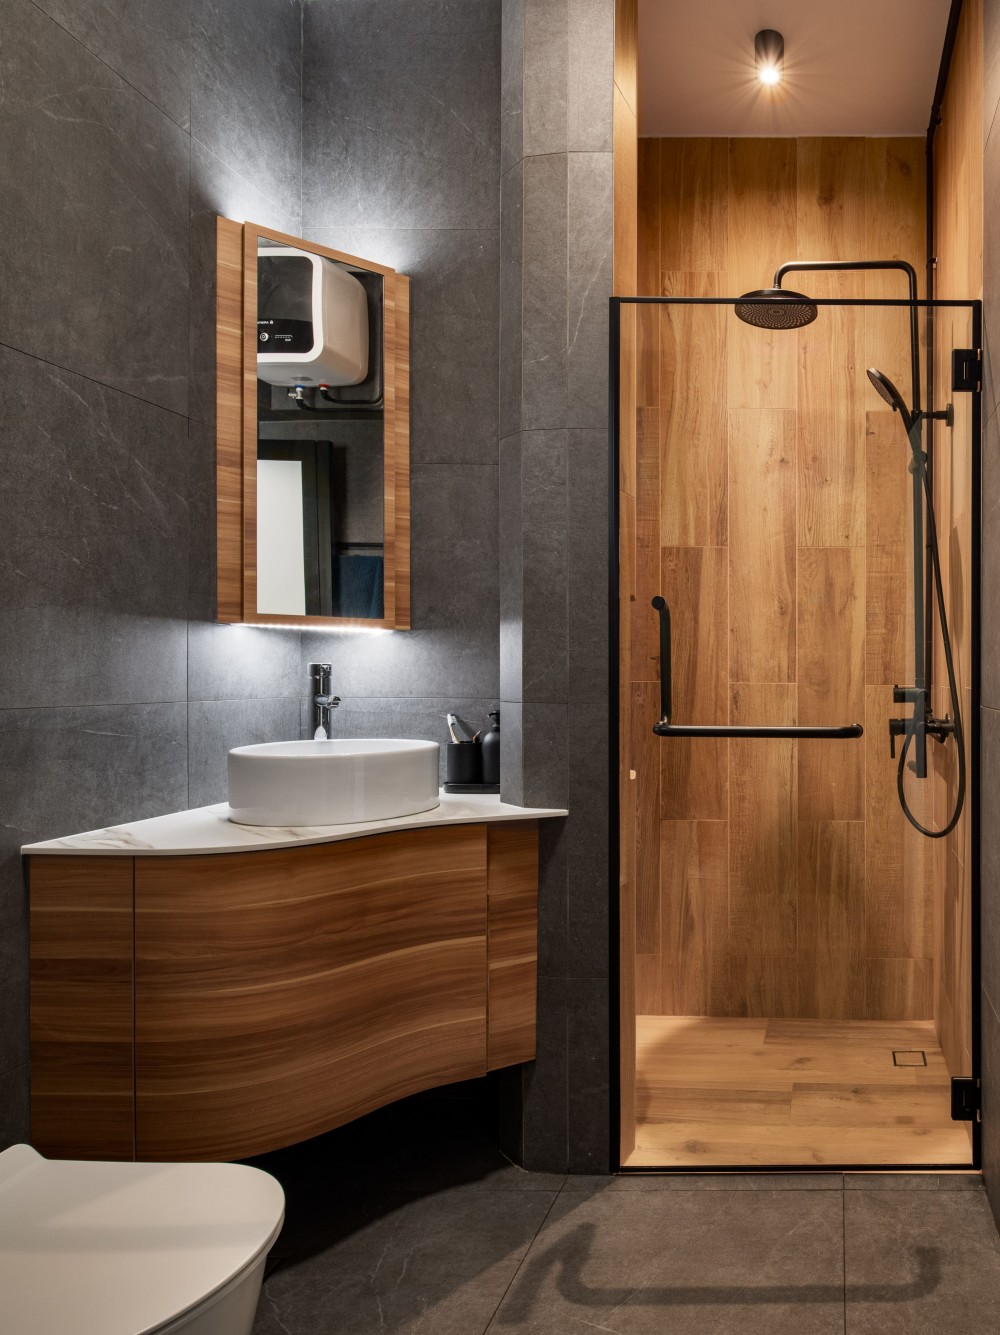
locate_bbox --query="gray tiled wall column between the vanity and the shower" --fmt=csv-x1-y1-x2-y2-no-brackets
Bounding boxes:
499,0,614,1172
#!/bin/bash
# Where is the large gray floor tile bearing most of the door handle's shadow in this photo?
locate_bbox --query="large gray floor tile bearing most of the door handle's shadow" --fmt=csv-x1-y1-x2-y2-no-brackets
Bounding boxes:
490,1191,844,1335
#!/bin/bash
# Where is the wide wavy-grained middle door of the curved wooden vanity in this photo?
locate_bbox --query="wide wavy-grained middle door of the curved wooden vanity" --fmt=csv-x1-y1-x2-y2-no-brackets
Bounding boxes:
135,825,487,1159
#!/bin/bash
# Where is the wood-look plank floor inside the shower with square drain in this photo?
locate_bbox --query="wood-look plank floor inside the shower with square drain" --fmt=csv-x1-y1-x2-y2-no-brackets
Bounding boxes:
628,1016,971,1168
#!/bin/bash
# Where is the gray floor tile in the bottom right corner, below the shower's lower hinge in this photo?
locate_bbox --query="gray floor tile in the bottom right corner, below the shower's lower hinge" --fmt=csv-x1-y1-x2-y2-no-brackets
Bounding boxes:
844,1191,1000,1335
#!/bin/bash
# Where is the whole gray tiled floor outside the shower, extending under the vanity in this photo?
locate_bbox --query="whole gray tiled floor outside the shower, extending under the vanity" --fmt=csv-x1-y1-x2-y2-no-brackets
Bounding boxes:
251,1083,1000,1335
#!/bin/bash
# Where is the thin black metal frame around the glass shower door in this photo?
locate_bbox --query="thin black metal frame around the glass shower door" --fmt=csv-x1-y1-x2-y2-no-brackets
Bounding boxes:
607,296,983,1173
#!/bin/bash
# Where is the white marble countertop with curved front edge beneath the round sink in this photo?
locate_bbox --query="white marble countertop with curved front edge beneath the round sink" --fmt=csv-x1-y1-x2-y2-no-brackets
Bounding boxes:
21,792,569,857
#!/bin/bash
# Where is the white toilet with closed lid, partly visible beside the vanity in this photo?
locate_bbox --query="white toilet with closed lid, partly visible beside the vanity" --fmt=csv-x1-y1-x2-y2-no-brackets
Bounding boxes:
0,1145,284,1335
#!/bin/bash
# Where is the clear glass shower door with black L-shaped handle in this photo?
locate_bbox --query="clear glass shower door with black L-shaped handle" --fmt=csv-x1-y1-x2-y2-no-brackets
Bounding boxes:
618,300,979,1171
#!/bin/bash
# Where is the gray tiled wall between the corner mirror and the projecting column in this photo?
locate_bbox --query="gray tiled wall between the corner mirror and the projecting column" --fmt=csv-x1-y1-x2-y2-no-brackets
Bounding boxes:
295,0,501,779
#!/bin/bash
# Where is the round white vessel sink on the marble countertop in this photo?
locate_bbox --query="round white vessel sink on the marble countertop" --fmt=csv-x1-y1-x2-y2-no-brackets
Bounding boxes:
228,738,441,826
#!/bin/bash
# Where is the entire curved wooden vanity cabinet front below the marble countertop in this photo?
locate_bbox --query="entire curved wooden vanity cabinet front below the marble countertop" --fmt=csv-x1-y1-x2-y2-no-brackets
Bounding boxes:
28,821,538,1160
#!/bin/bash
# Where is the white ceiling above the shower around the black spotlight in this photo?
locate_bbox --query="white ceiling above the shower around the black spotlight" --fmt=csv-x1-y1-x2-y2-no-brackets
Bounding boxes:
638,0,951,136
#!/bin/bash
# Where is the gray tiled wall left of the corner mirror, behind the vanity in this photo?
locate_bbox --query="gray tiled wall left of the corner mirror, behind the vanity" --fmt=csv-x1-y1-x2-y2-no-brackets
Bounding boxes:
0,0,302,1145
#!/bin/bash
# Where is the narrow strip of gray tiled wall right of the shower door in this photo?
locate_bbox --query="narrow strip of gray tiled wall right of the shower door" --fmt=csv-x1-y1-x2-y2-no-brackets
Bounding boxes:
980,0,1000,1223
